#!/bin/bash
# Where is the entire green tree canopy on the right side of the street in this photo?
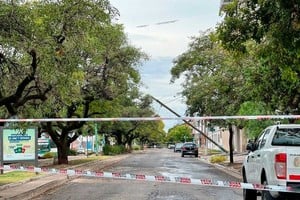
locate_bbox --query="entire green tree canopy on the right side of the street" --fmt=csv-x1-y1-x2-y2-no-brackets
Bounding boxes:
171,0,300,141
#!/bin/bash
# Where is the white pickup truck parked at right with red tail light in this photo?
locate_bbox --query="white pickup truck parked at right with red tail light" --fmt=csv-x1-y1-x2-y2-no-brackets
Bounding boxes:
242,124,300,200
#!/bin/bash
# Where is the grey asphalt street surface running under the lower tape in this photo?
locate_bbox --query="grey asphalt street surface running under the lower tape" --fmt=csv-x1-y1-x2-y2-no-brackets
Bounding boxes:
35,149,242,200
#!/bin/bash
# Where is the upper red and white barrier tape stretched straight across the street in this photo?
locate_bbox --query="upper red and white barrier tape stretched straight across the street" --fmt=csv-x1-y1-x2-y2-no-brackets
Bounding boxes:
0,115,300,122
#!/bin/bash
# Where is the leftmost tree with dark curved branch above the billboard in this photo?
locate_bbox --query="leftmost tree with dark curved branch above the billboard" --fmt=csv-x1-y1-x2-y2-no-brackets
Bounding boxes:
0,1,52,120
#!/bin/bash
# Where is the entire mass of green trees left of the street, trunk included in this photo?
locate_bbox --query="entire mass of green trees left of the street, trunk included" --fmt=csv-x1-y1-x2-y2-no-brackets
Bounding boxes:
0,0,162,164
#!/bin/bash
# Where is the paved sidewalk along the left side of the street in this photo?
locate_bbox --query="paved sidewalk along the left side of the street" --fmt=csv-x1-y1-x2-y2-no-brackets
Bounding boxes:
0,154,128,200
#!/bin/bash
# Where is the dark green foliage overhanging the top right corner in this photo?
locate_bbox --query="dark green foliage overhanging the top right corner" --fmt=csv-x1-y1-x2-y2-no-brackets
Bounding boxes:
218,0,300,53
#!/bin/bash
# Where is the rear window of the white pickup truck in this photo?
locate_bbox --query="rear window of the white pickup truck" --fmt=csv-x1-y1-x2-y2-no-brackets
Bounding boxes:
272,128,300,146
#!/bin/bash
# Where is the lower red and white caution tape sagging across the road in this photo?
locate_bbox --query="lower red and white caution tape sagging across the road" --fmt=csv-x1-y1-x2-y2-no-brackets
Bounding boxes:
0,165,300,193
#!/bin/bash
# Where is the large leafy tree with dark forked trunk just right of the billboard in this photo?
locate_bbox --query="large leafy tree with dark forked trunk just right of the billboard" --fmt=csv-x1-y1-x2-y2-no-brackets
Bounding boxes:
0,0,145,164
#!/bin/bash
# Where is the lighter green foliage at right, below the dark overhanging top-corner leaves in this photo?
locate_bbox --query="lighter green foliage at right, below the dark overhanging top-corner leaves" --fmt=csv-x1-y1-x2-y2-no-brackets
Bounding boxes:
171,16,300,133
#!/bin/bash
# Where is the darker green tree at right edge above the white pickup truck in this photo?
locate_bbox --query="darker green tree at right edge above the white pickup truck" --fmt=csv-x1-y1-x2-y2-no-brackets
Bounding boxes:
217,0,300,114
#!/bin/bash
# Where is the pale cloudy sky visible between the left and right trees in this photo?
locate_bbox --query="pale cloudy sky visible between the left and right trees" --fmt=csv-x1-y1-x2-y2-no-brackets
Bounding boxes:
110,0,221,131
